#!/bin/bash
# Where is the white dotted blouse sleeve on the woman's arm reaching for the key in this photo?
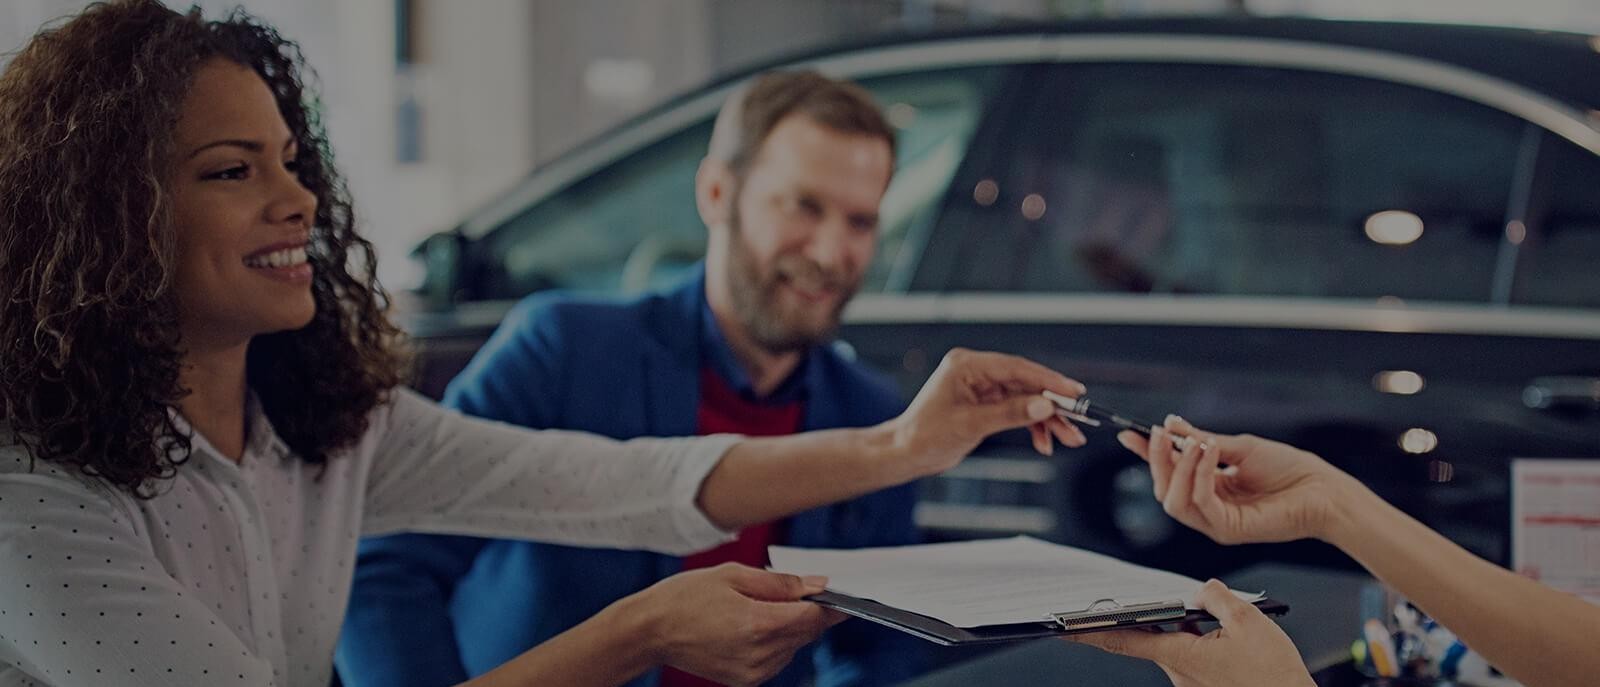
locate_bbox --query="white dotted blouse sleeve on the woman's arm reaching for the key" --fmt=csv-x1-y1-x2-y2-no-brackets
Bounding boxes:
363,389,739,554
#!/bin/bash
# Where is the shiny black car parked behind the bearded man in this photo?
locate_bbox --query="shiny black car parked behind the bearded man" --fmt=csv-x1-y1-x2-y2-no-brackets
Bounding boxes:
408,18,1600,573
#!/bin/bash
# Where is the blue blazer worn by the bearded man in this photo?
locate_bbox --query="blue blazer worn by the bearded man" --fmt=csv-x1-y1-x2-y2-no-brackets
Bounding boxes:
336,271,926,687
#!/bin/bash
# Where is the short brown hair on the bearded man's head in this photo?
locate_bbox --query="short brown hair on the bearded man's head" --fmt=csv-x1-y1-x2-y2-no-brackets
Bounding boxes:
706,70,894,178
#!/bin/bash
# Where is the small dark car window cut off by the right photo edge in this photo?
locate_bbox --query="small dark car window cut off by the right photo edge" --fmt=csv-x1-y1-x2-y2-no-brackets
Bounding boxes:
1515,135,1600,307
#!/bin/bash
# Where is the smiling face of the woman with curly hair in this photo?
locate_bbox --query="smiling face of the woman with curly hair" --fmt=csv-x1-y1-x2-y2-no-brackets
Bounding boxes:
168,59,317,349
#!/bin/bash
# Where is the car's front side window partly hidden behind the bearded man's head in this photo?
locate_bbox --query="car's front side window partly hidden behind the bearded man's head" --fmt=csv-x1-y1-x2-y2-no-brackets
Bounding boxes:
474,67,1000,299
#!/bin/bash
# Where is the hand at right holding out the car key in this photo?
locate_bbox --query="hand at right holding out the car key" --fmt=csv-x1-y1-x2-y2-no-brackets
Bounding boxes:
1117,415,1362,544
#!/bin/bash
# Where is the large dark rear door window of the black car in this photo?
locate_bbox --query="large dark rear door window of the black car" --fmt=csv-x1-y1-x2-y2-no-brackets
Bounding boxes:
938,64,1522,301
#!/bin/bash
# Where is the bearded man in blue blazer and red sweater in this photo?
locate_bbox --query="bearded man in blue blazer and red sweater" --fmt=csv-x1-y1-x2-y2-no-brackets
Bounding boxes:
336,72,926,687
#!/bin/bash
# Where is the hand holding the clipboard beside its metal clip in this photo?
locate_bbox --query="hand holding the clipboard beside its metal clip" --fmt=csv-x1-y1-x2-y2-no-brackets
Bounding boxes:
1067,580,1314,687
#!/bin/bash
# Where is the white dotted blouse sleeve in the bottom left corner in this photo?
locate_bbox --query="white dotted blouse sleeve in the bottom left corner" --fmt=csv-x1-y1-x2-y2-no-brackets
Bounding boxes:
0,468,274,687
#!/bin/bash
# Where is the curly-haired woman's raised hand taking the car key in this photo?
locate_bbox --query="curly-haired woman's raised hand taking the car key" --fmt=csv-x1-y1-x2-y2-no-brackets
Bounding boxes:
888,349,1085,476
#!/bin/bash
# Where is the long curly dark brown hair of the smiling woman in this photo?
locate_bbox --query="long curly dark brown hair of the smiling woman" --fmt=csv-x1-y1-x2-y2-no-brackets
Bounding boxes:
0,0,408,498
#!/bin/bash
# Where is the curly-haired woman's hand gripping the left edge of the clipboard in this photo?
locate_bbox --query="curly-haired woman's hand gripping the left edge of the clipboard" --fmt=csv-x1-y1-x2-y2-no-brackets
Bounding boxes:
619,564,845,685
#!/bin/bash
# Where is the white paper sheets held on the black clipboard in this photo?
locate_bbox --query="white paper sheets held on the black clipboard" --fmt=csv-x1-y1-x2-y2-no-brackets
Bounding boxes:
770,536,1262,628
